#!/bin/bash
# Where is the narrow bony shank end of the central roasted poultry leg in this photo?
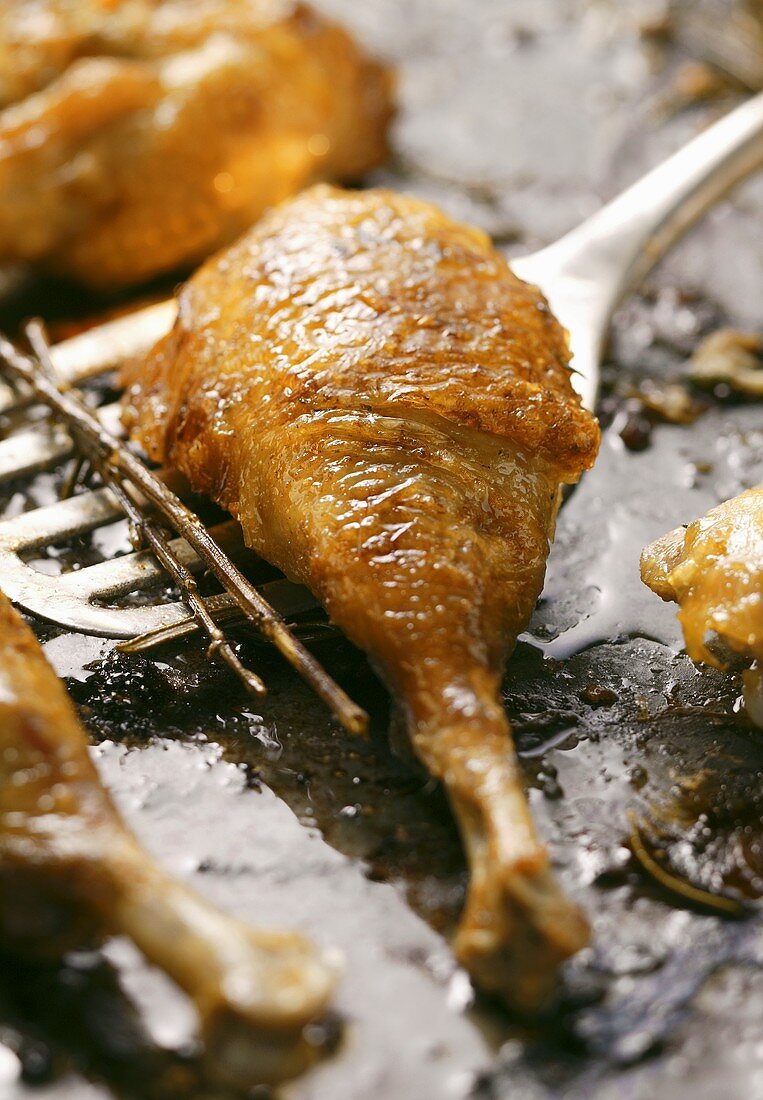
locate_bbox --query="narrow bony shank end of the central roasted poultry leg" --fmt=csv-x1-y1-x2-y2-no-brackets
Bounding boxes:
414,707,588,1008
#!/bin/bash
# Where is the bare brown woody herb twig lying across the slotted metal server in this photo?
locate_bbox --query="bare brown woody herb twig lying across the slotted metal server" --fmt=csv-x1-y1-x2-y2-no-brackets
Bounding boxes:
0,322,368,733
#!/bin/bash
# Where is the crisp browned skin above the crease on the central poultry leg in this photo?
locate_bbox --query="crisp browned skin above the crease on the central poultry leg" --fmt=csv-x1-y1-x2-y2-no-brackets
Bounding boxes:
128,186,599,477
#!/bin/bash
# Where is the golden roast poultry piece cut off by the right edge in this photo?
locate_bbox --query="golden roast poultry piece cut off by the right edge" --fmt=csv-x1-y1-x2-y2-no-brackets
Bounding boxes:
641,485,763,668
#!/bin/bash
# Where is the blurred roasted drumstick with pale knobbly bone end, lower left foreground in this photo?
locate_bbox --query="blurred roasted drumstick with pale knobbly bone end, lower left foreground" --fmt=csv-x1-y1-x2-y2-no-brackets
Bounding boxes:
0,594,335,1086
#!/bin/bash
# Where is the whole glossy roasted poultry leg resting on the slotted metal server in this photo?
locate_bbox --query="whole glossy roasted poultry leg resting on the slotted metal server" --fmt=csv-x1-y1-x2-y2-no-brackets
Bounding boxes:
125,186,598,1009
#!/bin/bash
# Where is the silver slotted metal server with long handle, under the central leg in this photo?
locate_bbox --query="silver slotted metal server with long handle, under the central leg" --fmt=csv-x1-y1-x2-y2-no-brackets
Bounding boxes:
0,94,763,638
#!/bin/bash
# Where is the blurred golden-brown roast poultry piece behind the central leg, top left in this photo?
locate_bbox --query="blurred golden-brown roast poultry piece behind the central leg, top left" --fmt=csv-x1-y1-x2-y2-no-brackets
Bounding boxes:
0,0,390,288
